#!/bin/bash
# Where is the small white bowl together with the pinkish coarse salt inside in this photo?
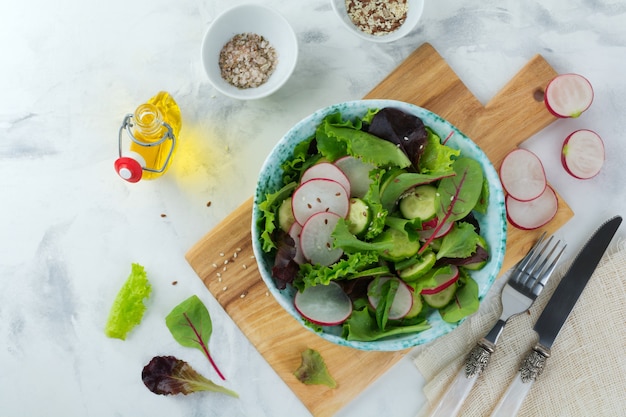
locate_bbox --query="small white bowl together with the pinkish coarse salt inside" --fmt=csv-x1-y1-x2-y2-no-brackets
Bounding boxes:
201,4,298,100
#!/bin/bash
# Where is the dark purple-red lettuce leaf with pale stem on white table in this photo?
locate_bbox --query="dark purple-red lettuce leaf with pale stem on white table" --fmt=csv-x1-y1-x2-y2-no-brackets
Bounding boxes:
141,356,239,398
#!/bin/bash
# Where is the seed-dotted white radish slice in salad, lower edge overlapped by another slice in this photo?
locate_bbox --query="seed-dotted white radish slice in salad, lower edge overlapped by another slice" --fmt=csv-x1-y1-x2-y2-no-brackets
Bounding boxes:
291,179,350,225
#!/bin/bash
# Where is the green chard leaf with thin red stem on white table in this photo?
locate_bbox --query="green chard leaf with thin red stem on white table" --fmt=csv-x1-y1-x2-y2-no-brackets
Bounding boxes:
165,295,226,380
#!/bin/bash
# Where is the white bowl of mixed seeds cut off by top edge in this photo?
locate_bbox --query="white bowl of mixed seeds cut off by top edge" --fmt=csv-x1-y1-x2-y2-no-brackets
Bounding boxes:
331,0,424,42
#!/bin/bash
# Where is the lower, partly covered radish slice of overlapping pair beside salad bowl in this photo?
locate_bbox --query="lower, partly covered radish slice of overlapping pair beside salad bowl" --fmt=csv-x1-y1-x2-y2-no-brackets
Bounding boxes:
505,186,559,230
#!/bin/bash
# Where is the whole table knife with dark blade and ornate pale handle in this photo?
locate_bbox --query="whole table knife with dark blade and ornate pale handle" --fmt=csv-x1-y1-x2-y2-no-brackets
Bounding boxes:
491,216,622,417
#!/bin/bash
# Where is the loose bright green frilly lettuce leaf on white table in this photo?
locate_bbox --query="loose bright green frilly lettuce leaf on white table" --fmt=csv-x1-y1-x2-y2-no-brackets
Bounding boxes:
104,263,152,340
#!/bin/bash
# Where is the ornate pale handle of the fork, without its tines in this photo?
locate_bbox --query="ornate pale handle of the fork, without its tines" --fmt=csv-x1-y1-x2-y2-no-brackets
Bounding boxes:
422,338,495,417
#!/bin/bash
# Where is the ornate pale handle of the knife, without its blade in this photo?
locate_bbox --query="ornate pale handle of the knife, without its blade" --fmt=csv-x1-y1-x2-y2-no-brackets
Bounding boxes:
491,343,550,417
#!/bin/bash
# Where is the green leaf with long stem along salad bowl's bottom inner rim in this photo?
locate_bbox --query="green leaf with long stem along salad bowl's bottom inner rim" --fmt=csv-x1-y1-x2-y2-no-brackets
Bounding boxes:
343,306,430,342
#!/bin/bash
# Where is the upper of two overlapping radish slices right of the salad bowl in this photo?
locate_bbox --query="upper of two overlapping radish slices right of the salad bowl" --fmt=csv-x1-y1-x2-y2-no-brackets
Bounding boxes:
500,148,547,201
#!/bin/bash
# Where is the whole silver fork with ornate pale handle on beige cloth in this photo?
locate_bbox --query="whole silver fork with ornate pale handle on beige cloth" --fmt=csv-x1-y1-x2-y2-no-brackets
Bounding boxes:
428,232,565,417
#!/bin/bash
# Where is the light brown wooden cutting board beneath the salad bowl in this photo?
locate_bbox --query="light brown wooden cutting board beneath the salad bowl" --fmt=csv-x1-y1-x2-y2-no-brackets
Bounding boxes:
186,44,573,416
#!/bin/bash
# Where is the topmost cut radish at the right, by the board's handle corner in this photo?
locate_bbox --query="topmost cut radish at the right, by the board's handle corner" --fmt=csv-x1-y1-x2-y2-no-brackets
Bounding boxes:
544,74,593,118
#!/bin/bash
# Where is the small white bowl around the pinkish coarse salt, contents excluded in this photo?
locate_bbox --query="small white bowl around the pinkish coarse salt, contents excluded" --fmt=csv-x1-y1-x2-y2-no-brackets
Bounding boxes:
201,3,298,100
